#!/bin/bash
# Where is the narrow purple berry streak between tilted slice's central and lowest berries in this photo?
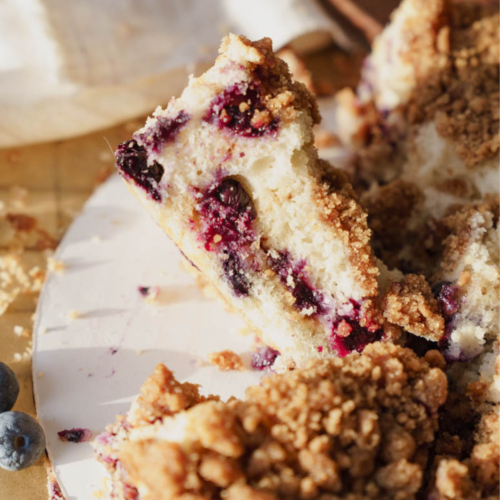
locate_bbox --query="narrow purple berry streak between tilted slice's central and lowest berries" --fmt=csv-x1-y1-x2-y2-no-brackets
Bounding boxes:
268,251,325,316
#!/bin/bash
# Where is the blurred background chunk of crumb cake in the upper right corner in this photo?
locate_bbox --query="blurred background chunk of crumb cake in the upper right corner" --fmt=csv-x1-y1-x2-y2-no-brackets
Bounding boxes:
330,0,500,272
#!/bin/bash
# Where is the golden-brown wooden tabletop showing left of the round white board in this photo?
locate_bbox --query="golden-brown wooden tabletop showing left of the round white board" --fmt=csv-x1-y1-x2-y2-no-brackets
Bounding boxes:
0,119,143,500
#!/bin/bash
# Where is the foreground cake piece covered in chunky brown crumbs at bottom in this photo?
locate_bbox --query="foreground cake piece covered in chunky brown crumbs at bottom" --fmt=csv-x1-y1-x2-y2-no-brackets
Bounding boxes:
94,343,447,500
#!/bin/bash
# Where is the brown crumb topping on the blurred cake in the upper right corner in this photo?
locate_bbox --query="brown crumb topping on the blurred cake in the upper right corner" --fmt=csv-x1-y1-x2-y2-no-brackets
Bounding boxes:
408,2,500,167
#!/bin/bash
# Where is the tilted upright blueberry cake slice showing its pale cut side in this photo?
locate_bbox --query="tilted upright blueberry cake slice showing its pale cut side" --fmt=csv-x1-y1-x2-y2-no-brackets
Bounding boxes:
116,35,389,367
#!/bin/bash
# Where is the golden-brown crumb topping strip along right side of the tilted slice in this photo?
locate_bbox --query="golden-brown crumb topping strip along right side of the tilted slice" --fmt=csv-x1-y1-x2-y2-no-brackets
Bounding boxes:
314,162,379,297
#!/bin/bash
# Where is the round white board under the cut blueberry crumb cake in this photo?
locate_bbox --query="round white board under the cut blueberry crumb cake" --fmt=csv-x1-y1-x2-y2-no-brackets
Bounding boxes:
33,176,261,500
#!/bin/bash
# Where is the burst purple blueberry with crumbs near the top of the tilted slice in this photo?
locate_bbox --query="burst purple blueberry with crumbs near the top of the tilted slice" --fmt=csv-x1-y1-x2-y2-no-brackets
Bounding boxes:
204,82,278,137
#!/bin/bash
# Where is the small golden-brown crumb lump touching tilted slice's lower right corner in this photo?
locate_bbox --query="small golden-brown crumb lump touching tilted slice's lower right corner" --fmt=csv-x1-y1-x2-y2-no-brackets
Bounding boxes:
382,274,444,341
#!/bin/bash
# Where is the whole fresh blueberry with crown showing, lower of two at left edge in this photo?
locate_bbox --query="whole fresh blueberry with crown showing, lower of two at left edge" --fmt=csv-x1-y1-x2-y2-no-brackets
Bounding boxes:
0,411,45,471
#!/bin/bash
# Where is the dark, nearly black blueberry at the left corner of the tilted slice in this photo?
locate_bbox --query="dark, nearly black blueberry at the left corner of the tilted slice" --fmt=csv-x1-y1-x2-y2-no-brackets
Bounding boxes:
115,141,164,201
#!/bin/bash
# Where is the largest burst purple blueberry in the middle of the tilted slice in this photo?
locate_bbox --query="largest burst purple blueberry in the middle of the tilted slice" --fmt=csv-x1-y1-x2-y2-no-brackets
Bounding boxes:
195,178,256,297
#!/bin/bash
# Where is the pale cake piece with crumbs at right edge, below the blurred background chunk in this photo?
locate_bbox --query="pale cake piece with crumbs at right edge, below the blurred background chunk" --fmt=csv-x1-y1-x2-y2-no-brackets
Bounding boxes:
433,196,500,403
